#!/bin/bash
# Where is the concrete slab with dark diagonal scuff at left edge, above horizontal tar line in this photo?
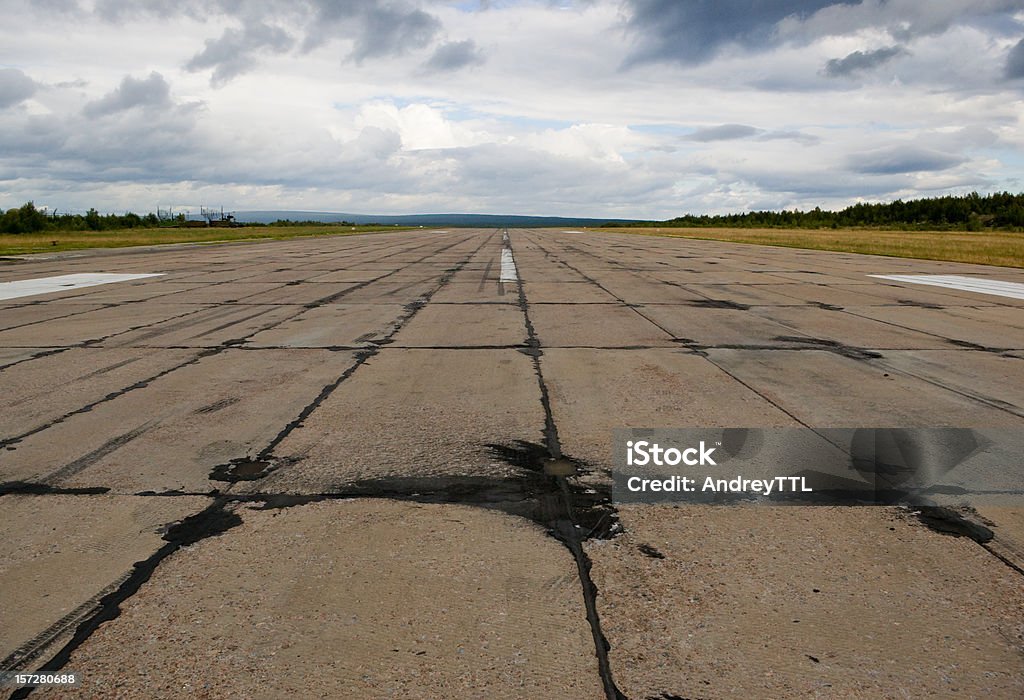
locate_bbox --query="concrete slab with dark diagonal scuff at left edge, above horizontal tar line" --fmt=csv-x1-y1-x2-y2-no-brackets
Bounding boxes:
0,350,353,493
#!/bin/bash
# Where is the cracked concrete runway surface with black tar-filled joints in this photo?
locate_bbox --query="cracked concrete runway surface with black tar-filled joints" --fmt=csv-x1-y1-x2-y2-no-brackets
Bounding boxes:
6,230,1024,699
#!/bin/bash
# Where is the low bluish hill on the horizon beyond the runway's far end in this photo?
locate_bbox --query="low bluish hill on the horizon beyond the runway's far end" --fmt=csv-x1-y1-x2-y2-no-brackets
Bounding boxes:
234,211,636,228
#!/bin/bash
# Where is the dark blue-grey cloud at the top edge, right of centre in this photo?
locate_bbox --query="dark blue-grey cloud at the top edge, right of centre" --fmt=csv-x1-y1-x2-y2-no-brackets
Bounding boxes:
626,0,859,65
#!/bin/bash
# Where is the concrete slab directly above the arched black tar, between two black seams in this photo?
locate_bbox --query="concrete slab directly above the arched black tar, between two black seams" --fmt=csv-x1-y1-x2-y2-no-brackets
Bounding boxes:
251,348,544,493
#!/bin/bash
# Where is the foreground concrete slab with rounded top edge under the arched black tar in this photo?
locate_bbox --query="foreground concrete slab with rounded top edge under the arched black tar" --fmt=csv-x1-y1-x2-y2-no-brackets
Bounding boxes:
32,499,601,700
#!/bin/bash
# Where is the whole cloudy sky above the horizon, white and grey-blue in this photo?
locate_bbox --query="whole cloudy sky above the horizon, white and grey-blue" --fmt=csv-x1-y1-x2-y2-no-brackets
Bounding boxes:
0,0,1024,218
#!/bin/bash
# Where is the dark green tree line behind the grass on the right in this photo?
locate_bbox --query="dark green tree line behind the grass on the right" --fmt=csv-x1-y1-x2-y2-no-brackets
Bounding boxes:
609,192,1024,231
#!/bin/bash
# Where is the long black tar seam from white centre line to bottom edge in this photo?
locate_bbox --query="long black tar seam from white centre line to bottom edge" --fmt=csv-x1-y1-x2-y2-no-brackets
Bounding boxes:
505,229,626,700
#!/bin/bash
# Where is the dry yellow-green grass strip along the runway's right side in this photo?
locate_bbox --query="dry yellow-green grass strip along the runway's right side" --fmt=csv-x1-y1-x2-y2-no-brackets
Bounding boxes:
595,228,1024,267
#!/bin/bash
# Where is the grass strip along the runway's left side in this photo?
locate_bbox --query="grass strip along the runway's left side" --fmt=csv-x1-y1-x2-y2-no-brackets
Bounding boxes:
0,226,408,255
